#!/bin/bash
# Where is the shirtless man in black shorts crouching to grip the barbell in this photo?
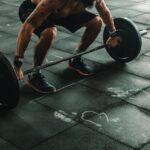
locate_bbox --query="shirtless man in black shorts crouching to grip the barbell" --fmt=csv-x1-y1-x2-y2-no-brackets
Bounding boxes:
14,0,118,93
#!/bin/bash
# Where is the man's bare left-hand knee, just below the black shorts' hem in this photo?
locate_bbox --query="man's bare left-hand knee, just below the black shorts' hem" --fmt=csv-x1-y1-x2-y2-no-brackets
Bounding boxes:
41,27,57,40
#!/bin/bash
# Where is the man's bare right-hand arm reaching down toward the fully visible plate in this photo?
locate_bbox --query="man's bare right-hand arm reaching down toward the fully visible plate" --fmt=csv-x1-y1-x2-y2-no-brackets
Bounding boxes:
96,0,116,32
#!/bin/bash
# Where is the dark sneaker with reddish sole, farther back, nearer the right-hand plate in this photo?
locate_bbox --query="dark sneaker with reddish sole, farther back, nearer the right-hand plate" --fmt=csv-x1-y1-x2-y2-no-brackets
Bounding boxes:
68,57,93,76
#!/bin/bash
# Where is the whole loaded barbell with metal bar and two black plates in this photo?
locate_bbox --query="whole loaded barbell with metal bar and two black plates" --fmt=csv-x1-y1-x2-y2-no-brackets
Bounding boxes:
0,18,147,112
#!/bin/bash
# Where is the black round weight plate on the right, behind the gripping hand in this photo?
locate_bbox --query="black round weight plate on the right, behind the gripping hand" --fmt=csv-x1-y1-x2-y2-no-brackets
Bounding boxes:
103,18,142,63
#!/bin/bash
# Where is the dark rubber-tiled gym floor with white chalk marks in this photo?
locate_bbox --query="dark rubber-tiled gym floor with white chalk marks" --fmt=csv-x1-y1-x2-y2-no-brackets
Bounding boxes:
0,0,150,150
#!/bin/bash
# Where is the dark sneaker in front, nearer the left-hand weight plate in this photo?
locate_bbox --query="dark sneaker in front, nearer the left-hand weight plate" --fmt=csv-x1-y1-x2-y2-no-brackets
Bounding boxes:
26,73,56,93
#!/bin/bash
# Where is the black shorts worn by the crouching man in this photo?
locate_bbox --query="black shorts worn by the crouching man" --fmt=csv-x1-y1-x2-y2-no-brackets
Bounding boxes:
19,0,96,36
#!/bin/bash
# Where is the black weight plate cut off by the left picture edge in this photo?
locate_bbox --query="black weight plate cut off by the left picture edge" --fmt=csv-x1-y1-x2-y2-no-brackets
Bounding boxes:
0,53,20,112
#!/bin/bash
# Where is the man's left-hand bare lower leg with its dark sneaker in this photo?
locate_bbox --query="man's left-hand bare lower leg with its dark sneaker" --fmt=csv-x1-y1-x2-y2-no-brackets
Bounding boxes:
26,27,57,93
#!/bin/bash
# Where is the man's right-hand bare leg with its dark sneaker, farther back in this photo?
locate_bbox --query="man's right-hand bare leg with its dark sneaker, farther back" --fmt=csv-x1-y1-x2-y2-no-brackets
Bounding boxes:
69,16,102,76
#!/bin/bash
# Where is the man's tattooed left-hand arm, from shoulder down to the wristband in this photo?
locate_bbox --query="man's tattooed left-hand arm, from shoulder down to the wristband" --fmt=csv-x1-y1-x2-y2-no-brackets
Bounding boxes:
16,0,57,57
